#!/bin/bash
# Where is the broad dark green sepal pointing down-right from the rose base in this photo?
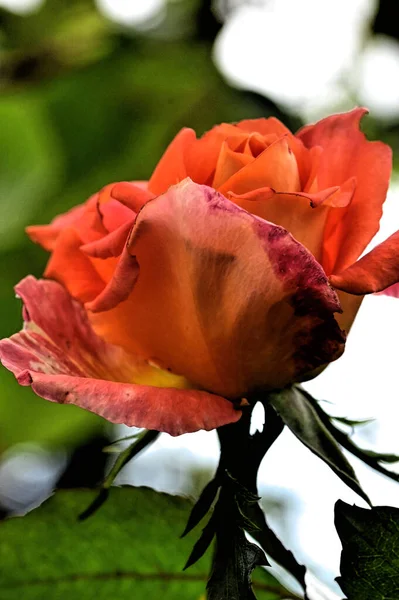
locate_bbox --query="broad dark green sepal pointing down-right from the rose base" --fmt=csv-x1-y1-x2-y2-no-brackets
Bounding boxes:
269,387,370,504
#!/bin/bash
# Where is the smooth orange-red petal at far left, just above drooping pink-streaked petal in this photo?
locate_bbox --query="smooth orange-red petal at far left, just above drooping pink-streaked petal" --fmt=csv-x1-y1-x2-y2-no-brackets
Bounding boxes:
44,228,105,302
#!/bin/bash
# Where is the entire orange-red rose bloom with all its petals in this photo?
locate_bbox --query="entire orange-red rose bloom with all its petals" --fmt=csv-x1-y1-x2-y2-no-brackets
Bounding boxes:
1,109,399,435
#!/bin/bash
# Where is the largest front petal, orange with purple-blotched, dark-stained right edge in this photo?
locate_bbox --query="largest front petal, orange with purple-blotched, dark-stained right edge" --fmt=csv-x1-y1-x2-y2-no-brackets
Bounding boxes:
95,180,344,399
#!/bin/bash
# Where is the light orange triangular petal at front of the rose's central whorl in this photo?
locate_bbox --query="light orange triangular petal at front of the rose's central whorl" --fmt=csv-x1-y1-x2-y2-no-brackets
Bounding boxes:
218,137,300,195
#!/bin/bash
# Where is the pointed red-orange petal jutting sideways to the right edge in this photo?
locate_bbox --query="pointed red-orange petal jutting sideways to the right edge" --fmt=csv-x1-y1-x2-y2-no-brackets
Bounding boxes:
330,231,399,295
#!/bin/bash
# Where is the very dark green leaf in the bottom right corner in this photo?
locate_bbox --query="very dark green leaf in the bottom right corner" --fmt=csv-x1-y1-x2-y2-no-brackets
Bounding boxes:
335,500,399,600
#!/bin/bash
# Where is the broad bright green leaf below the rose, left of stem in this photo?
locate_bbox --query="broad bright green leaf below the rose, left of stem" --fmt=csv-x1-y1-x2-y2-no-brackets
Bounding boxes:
0,487,290,600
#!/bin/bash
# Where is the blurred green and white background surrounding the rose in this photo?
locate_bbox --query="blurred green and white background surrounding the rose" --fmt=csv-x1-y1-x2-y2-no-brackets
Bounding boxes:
0,0,399,599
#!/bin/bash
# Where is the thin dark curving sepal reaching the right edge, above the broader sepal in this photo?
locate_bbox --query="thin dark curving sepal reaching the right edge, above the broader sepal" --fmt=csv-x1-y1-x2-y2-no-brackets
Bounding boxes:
298,388,399,481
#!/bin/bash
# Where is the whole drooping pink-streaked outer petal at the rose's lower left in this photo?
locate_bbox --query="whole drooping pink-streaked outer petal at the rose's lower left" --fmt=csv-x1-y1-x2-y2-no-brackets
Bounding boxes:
0,277,241,435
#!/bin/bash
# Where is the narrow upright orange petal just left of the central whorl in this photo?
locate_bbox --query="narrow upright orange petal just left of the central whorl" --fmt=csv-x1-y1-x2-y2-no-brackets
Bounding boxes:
148,128,196,196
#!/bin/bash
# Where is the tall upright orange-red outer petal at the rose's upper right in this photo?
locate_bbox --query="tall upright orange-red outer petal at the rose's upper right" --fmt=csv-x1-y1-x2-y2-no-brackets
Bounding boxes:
297,108,392,274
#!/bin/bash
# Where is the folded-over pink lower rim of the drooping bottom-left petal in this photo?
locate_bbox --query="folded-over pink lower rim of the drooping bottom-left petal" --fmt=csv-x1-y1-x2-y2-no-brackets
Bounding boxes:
16,373,241,436
